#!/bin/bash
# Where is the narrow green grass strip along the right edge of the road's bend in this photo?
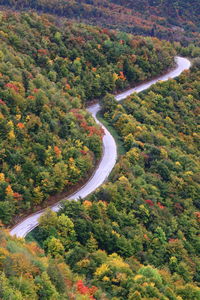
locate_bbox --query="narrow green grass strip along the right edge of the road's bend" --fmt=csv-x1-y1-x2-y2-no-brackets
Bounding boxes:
97,111,126,156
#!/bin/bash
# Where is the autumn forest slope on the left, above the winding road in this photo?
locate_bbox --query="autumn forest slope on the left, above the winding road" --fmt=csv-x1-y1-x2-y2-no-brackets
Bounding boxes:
0,12,175,224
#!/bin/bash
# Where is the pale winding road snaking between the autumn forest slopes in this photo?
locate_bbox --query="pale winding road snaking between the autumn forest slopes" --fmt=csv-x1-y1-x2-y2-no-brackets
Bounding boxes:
10,57,191,238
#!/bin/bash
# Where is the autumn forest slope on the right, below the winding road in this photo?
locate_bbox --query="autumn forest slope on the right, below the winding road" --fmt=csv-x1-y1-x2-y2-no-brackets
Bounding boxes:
30,67,200,300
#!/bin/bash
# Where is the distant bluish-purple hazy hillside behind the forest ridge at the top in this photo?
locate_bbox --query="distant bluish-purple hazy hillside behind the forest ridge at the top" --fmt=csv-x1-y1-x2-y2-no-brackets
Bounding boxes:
0,0,200,44
